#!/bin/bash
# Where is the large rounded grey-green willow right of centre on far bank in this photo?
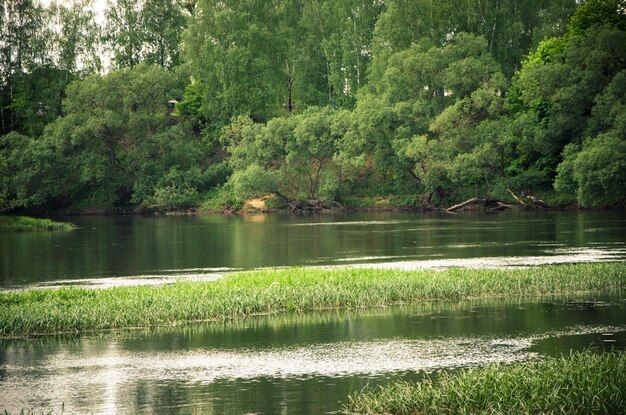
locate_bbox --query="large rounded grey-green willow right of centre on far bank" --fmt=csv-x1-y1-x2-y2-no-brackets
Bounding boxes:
340,33,506,199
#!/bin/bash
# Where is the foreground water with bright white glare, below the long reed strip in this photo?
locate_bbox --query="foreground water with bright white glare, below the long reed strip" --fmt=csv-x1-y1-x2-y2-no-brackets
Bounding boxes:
0,297,626,414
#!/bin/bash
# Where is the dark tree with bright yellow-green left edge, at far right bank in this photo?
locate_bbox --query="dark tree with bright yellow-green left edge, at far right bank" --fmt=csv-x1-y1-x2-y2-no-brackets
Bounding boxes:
510,27,626,184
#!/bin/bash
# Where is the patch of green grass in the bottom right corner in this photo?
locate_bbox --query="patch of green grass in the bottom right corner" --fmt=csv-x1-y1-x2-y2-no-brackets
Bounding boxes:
343,351,626,415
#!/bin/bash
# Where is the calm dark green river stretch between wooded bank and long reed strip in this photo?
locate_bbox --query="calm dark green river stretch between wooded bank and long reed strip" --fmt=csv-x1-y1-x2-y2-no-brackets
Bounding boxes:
0,212,626,288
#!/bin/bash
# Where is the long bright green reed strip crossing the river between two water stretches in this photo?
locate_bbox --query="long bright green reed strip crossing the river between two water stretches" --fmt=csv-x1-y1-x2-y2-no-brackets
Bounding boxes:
0,262,626,336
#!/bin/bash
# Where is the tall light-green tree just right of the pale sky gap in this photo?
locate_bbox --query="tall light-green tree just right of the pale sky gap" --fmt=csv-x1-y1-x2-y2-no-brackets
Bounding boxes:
185,0,285,127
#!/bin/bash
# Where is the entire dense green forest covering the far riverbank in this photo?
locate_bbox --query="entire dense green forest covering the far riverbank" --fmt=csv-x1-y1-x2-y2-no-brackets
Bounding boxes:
0,0,626,212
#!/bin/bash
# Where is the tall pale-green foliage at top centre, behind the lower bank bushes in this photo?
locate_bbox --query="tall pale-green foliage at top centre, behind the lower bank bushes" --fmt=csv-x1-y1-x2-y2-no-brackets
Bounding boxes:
184,0,383,128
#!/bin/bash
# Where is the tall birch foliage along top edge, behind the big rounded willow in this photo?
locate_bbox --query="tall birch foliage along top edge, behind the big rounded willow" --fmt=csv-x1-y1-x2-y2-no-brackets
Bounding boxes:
370,0,577,84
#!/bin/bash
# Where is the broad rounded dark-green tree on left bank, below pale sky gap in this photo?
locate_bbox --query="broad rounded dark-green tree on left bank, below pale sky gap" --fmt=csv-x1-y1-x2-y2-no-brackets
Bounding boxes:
30,65,180,209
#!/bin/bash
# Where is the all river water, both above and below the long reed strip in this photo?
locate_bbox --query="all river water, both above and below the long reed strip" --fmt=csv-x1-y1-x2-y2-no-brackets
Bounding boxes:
0,212,626,414
